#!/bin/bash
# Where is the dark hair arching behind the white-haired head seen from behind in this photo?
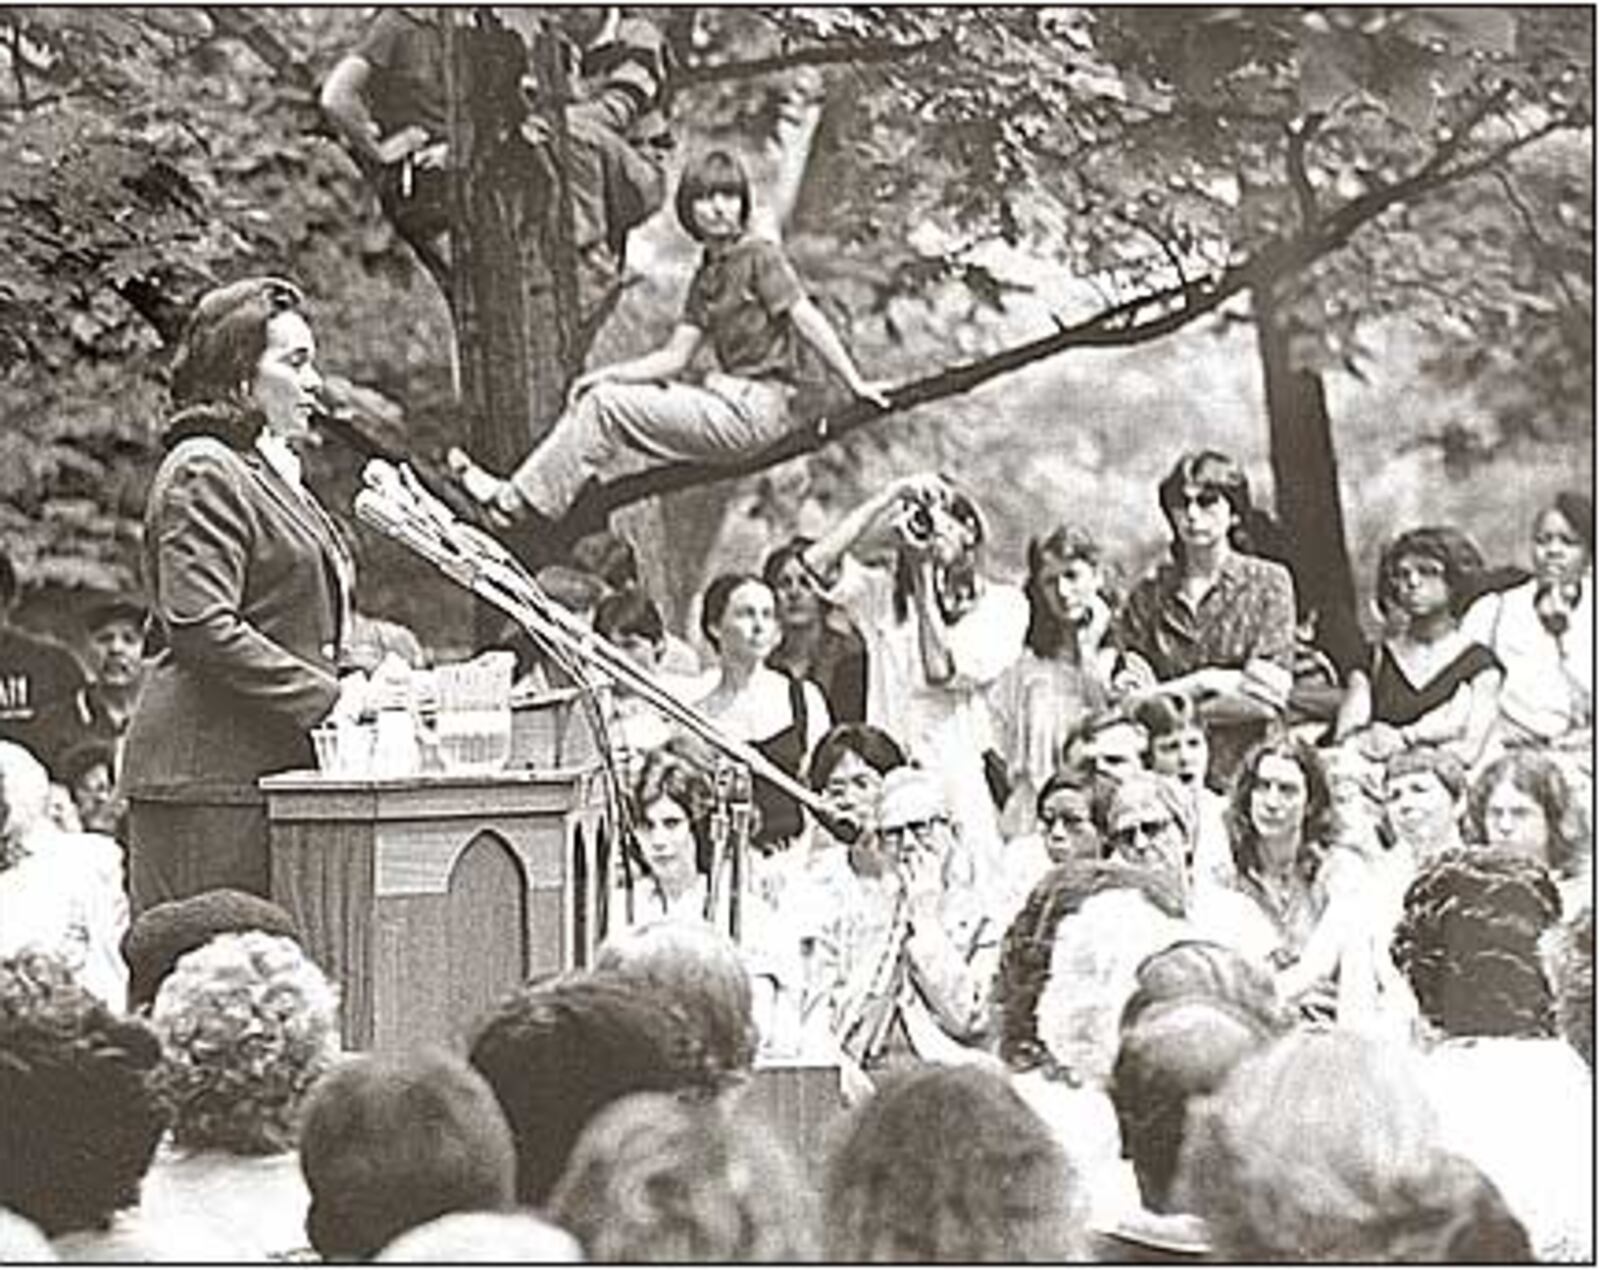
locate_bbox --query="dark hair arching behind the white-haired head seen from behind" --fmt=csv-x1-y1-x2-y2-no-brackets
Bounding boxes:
994,861,1184,1072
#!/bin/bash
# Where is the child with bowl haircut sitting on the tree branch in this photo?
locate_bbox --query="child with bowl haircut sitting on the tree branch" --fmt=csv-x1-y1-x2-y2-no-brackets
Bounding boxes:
448,150,890,558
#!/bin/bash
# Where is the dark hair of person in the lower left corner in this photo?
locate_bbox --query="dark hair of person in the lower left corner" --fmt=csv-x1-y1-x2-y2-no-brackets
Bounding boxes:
0,953,166,1236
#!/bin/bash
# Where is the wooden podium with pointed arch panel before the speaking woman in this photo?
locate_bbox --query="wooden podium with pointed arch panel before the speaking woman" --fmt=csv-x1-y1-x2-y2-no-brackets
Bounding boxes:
261,766,608,1051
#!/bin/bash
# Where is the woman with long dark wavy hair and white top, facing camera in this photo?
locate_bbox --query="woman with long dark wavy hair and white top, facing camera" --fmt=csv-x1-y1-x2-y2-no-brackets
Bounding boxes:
1195,733,1373,1016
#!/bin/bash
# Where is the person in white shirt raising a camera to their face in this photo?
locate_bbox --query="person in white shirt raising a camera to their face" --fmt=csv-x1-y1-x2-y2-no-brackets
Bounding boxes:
800,475,1029,883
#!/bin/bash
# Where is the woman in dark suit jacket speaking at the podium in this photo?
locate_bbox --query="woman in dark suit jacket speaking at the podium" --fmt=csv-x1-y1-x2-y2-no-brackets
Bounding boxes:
122,278,362,912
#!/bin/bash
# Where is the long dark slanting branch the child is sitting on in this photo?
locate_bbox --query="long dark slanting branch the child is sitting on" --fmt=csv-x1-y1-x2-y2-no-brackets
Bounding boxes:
573,88,1576,518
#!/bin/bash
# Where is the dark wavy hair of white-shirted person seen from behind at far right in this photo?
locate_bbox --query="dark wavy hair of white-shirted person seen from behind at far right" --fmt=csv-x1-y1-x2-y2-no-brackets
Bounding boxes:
1390,848,1562,1036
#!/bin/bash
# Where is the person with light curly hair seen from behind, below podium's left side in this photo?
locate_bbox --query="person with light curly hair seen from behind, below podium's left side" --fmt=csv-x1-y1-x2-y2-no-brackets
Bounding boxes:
141,931,339,1259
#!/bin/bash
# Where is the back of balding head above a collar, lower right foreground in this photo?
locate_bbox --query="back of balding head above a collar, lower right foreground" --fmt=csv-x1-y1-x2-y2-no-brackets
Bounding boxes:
1109,996,1272,1212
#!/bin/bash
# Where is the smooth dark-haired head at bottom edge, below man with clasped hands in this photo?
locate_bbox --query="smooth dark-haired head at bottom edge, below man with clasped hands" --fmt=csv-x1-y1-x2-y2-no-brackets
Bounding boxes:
822,1065,1085,1264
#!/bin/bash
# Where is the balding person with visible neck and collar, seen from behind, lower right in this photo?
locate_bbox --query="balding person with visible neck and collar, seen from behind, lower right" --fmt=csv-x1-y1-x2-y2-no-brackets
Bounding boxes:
1096,996,1272,1262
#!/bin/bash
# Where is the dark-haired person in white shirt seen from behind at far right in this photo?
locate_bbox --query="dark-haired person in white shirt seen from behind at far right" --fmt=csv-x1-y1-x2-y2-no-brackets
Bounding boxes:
1394,848,1594,1260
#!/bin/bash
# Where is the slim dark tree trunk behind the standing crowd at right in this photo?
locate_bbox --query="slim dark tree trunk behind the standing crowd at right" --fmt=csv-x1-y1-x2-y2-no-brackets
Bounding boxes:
1251,285,1363,672
